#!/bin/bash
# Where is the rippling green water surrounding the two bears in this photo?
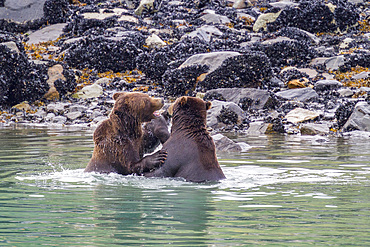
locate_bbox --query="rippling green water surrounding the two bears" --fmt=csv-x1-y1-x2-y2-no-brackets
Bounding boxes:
0,128,370,246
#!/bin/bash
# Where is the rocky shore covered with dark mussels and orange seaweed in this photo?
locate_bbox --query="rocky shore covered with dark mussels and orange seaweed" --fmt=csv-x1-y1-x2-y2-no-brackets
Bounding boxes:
0,0,370,140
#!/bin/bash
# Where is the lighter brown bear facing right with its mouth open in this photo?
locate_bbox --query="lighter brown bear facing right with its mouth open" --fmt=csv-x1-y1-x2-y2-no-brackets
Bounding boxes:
85,92,168,175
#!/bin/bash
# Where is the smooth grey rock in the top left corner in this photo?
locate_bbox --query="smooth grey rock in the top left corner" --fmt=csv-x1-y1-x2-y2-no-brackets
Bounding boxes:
0,0,46,22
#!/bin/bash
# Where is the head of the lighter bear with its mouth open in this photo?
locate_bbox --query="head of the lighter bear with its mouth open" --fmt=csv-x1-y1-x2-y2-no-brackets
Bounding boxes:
112,92,164,122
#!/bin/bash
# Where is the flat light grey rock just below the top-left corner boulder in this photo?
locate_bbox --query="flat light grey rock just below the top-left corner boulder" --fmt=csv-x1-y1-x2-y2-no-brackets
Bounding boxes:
27,23,67,44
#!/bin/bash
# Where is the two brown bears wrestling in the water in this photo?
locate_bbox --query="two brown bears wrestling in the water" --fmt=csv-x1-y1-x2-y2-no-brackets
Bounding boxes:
85,92,225,182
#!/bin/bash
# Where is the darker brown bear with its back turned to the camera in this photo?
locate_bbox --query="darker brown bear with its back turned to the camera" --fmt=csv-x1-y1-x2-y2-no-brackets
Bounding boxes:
144,96,225,182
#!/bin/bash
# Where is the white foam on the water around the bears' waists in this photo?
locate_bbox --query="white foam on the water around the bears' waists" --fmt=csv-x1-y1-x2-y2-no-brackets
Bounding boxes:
16,157,369,196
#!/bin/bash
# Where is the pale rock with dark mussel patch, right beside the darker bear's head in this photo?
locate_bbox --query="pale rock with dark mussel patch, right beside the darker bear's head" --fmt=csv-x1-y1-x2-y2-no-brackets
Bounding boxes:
207,100,244,128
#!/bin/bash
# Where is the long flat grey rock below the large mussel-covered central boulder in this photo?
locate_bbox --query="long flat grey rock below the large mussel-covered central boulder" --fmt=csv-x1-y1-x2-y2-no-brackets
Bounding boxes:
206,88,273,110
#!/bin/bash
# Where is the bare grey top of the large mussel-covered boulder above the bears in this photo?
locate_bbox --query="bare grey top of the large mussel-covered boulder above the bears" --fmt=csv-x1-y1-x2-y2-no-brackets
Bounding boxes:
179,51,242,73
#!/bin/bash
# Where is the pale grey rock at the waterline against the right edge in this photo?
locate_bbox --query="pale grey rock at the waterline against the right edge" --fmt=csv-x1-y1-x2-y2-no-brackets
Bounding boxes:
343,101,370,131
